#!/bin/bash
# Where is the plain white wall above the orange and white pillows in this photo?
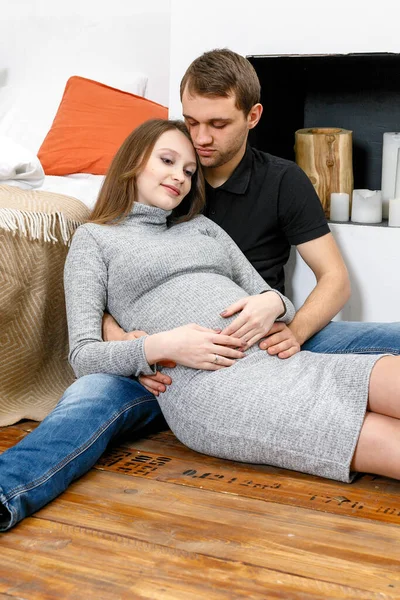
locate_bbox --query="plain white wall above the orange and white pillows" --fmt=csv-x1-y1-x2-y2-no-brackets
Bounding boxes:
0,0,170,105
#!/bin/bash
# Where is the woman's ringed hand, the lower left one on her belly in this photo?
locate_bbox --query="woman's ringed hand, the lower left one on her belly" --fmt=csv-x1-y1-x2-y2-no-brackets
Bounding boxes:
144,323,244,371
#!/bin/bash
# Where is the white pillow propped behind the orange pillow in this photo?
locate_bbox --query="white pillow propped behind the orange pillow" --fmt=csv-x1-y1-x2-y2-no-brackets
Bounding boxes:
0,73,148,154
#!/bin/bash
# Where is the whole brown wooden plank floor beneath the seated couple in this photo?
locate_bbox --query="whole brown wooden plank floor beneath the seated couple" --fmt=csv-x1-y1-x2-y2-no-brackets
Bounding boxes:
0,421,400,600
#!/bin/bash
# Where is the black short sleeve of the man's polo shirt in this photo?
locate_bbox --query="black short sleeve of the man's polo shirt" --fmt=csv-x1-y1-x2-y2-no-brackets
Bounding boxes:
278,164,330,246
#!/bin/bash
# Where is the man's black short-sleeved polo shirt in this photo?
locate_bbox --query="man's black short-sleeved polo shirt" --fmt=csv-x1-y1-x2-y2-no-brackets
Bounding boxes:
204,146,329,292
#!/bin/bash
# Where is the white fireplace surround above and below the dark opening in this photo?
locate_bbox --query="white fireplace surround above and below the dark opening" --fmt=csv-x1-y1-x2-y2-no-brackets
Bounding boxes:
169,0,400,321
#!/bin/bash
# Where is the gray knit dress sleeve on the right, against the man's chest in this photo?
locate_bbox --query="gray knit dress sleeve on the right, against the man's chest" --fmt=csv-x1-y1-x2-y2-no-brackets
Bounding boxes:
202,217,296,323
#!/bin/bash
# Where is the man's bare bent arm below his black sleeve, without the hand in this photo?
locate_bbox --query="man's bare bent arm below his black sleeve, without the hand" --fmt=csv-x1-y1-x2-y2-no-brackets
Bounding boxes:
289,233,351,345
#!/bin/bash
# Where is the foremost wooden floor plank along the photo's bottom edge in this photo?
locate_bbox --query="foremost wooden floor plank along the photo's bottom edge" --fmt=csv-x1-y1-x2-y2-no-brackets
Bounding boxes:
0,518,382,600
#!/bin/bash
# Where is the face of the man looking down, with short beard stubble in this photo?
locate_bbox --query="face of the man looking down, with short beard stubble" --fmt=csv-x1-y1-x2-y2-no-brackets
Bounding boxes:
182,90,249,168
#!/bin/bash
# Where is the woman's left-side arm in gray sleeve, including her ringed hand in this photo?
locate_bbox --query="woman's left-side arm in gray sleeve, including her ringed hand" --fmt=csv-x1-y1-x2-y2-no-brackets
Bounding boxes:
64,227,243,377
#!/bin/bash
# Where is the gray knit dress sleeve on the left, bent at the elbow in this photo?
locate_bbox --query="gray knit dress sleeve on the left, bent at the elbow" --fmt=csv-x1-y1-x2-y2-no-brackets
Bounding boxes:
64,226,155,377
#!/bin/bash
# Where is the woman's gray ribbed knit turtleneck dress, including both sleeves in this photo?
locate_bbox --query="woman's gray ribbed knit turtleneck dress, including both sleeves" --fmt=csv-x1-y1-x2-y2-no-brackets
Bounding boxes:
65,203,380,481
